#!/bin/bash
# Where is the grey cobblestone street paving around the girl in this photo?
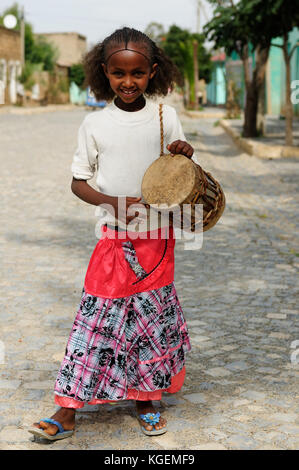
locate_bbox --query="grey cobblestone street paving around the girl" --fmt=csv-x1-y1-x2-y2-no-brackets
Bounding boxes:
0,104,299,450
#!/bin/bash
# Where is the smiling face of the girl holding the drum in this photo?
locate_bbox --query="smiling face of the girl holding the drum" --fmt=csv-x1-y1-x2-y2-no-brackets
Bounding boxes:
102,43,158,110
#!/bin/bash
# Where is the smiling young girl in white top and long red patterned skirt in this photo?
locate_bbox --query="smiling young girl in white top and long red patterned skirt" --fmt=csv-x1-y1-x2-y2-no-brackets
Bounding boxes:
30,28,193,440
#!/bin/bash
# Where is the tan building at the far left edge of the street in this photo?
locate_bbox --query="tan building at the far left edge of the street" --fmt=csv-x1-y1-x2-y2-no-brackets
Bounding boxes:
0,26,22,105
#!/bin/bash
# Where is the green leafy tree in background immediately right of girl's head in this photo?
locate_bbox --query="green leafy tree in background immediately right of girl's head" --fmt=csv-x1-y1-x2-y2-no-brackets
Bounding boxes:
162,25,212,103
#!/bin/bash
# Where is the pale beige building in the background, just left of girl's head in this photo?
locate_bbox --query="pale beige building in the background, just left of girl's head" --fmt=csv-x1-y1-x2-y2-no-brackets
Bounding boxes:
36,33,87,67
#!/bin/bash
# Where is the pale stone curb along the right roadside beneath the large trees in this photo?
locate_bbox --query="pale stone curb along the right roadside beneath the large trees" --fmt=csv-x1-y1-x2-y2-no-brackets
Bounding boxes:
219,119,299,159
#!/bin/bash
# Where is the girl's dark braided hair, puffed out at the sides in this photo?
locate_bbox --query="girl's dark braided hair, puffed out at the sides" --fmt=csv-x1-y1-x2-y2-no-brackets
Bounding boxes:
83,27,182,101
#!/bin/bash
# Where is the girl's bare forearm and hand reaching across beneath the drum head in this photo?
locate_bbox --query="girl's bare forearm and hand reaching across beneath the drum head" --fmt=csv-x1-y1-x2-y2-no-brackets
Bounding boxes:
71,178,141,225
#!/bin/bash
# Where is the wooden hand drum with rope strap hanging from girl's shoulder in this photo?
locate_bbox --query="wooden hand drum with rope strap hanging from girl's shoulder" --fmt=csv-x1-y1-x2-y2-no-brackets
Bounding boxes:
141,104,225,232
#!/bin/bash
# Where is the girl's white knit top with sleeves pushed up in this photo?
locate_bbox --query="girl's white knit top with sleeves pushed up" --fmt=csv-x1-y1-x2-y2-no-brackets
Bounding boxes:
71,100,199,229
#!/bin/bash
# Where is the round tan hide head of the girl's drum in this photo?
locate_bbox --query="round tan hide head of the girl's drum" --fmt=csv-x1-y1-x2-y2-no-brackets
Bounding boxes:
141,155,196,208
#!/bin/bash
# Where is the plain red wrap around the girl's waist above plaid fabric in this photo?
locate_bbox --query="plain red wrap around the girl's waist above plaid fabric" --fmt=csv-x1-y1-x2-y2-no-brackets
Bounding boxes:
84,226,175,299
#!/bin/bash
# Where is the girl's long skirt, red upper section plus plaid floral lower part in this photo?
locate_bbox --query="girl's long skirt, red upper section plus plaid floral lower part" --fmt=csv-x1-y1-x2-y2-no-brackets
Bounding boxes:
54,227,191,408
